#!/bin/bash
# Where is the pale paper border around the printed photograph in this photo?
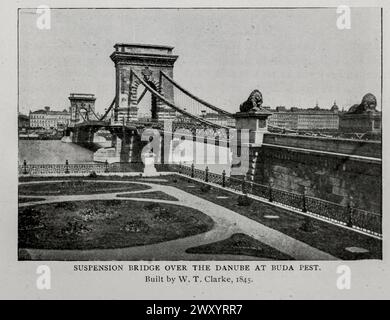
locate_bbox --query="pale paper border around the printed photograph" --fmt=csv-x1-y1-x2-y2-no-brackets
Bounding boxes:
0,0,390,300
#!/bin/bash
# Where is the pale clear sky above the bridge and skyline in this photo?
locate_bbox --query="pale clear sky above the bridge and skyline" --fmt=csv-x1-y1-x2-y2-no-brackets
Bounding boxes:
19,8,381,113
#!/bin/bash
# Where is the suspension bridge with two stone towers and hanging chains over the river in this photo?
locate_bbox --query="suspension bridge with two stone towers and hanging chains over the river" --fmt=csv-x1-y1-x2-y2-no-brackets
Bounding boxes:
69,44,251,166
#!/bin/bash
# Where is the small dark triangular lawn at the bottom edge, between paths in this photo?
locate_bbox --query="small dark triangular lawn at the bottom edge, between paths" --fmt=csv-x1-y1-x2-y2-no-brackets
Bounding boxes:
186,233,294,260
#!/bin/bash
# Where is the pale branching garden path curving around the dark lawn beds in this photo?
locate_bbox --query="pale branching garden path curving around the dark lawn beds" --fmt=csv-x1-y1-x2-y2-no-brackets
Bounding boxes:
19,180,337,261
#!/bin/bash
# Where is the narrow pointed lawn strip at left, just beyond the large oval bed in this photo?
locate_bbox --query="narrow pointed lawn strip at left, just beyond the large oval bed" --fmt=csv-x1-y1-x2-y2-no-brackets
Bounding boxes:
19,179,150,196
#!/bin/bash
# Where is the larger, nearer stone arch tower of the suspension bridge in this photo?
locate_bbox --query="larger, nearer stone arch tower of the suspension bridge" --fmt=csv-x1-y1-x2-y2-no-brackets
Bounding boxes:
110,43,178,122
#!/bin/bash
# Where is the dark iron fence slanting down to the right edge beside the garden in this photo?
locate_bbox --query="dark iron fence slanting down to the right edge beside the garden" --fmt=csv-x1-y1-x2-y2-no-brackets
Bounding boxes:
173,165,382,237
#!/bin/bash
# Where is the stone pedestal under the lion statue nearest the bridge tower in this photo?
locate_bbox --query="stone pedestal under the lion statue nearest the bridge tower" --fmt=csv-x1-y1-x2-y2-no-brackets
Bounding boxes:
234,110,272,145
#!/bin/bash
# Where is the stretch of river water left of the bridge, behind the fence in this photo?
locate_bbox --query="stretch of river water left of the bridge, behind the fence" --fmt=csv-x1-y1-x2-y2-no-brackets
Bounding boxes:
19,140,93,164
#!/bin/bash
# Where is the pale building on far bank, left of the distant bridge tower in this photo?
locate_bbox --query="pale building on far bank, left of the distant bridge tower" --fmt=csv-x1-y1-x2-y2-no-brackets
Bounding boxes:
29,107,70,129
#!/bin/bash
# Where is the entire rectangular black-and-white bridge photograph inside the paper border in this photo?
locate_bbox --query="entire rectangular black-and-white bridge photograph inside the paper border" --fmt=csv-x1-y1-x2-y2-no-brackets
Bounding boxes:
17,6,382,261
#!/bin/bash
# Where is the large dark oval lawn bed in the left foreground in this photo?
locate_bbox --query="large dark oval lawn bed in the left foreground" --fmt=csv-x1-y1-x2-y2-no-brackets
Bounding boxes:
18,200,214,249
